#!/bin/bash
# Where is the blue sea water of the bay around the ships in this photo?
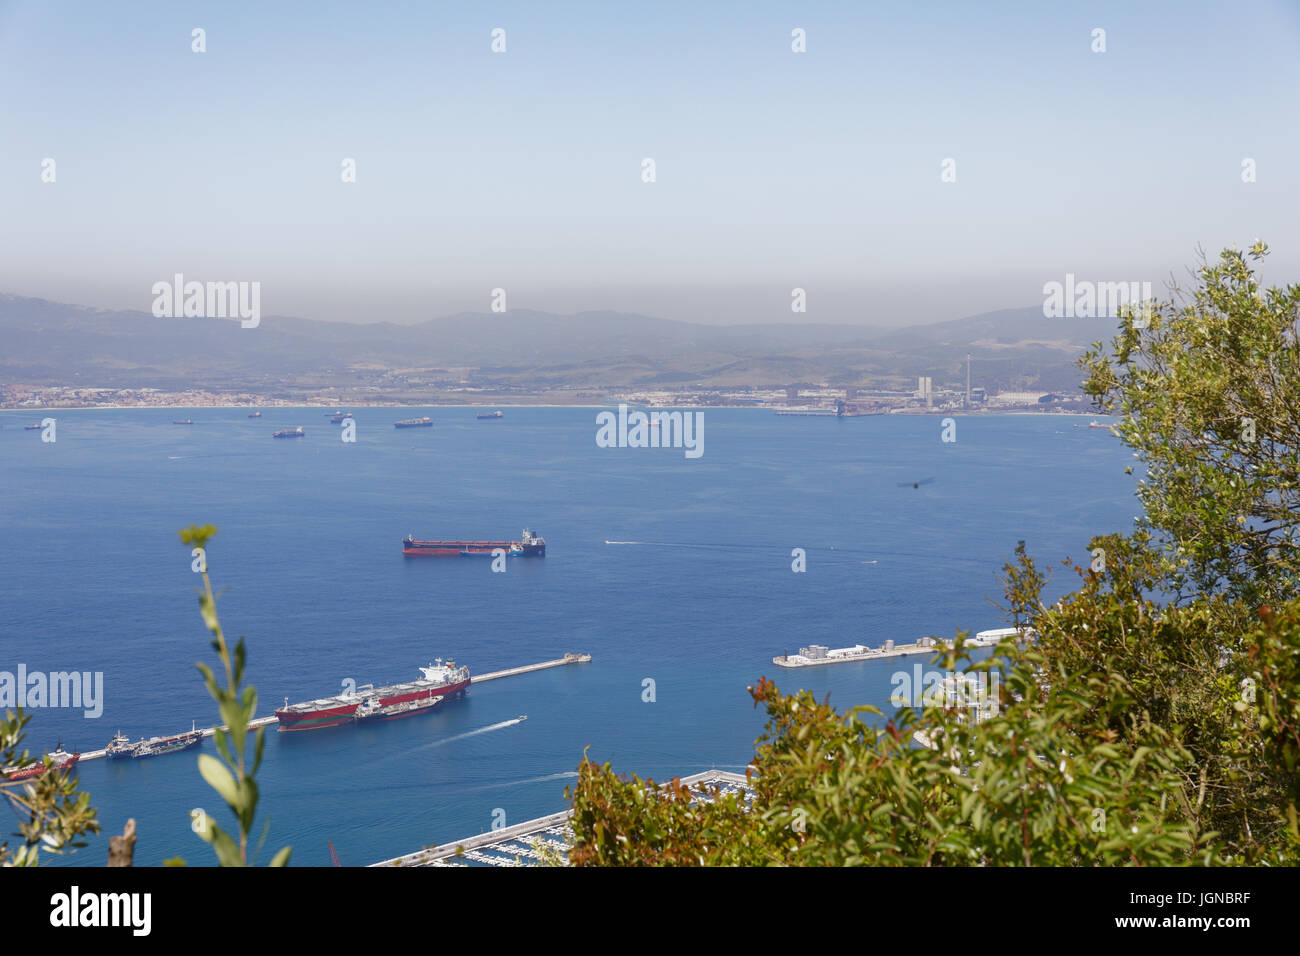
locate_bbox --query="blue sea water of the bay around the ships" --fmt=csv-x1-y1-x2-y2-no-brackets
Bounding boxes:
0,407,1138,865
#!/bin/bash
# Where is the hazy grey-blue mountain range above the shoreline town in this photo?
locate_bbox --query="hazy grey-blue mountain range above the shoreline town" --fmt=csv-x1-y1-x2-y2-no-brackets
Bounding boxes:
0,295,1115,390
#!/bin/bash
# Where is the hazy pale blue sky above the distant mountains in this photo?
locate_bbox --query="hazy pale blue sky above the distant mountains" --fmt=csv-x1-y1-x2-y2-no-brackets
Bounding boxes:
0,0,1300,324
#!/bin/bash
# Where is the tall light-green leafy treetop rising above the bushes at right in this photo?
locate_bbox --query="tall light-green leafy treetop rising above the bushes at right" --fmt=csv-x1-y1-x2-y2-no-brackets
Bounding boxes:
1083,242,1300,607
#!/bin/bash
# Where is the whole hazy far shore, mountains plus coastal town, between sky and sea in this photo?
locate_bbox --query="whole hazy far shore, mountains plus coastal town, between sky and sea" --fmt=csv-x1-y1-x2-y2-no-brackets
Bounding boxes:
0,294,1118,416
